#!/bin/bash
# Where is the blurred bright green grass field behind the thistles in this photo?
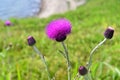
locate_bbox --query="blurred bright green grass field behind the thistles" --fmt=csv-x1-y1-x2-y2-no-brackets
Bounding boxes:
0,0,120,80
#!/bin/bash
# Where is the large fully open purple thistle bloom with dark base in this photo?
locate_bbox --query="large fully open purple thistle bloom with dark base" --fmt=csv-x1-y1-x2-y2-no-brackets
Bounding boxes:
46,18,72,42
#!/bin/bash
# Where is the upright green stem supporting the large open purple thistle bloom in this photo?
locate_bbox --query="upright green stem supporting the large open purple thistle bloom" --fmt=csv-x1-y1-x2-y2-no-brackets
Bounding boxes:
62,42,71,80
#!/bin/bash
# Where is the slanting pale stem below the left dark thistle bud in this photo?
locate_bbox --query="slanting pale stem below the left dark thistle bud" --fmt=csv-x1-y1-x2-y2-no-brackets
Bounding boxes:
33,45,51,80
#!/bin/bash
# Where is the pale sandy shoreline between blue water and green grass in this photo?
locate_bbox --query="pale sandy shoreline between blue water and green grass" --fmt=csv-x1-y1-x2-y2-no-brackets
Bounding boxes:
37,0,86,18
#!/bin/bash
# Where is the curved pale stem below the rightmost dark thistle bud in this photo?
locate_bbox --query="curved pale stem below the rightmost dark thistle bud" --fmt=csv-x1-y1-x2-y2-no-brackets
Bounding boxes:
87,38,107,70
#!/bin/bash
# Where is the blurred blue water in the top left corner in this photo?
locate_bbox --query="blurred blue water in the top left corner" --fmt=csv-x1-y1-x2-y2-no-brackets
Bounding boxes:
0,0,41,20
